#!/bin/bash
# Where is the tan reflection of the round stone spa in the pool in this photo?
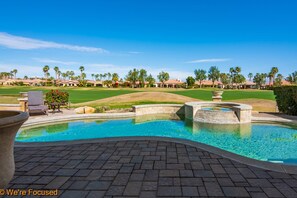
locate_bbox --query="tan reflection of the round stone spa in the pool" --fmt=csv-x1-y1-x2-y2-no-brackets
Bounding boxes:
185,119,252,138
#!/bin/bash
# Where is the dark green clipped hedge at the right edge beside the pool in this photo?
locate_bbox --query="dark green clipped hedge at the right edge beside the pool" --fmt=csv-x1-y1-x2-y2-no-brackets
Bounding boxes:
274,86,297,116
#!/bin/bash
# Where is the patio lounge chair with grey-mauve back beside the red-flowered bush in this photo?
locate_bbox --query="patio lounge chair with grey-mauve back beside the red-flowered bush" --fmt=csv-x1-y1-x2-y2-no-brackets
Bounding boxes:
28,91,48,115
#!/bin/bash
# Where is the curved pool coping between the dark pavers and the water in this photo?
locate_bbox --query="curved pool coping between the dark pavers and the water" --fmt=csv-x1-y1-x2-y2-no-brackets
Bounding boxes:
15,136,297,174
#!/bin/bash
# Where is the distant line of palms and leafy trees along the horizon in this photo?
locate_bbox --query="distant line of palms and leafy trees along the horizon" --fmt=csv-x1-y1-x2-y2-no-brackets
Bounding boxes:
0,65,297,88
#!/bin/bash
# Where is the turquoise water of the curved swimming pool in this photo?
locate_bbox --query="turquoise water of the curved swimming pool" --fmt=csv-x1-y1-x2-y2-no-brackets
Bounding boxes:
16,119,297,165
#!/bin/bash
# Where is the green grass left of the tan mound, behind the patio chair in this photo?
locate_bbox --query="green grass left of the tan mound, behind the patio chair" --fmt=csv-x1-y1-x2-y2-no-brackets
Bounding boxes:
0,87,137,103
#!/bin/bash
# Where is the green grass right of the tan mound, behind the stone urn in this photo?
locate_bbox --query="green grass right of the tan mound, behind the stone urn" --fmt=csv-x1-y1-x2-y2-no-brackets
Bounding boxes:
170,89,275,100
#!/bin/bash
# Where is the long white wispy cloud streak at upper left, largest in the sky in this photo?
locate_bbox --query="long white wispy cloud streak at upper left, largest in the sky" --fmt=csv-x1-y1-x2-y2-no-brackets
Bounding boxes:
0,32,108,53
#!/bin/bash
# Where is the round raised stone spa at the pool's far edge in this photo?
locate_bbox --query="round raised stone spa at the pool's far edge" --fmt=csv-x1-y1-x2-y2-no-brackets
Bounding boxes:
185,102,252,124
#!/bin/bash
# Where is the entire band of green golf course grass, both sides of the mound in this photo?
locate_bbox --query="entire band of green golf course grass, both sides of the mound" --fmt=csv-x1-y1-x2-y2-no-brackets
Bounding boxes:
0,87,275,105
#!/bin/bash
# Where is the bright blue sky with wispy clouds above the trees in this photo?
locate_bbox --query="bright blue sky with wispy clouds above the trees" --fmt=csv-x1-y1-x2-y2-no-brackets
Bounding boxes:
0,0,297,80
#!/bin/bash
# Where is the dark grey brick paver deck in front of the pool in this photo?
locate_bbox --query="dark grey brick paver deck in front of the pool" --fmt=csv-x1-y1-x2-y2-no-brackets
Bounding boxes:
9,140,297,198
